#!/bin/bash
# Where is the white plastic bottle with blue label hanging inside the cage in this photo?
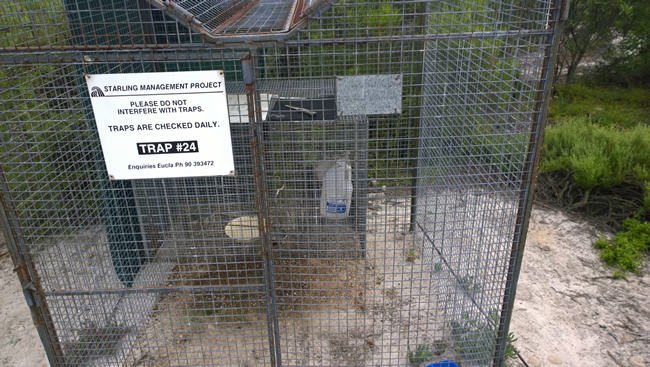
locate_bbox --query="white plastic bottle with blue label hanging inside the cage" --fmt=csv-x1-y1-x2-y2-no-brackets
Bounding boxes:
320,159,353,219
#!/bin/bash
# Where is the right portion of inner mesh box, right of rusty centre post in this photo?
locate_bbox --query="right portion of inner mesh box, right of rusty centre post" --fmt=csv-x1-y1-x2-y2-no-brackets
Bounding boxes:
264,96,368,258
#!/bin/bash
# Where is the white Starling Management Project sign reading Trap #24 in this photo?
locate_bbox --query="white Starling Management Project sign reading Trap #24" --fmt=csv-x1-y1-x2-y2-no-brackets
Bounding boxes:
86,70,235,180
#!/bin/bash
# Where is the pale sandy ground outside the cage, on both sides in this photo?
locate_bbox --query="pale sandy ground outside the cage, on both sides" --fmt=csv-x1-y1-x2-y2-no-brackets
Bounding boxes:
0,208,650,367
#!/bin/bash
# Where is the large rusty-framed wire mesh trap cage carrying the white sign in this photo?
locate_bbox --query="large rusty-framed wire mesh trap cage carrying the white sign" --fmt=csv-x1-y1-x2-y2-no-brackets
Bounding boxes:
0,0,564,366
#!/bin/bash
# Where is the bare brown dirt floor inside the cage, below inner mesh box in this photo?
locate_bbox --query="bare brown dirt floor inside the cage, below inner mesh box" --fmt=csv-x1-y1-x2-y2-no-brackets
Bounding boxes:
120,214,436,366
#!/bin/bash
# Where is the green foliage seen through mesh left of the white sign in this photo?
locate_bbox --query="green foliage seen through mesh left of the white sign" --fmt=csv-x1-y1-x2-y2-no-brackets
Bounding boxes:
0,0,100,242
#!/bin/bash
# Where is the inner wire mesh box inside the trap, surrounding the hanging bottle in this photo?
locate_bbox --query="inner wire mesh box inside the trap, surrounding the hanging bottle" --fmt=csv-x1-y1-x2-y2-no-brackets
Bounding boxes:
133,90,368,262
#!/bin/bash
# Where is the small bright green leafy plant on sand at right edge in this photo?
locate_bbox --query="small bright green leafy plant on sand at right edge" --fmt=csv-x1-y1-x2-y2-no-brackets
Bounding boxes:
594,218,650,277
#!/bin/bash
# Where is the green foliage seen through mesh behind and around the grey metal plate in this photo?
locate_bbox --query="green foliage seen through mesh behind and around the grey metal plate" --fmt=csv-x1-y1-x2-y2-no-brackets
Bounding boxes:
263,0,534,186
